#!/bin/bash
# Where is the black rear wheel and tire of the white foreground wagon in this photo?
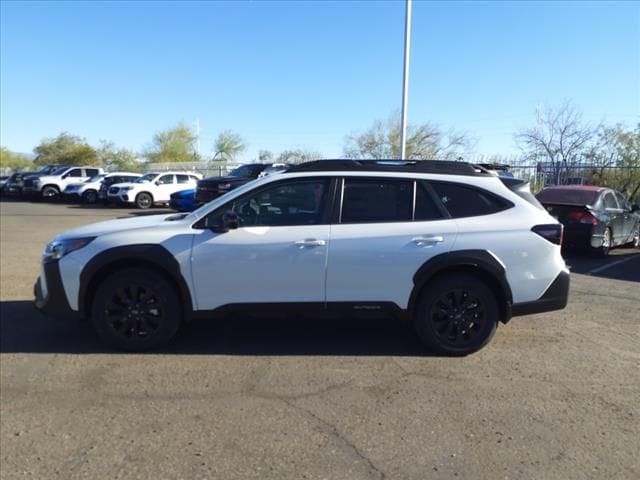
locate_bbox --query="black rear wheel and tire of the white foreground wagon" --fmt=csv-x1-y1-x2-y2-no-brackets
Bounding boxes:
414,273,500,356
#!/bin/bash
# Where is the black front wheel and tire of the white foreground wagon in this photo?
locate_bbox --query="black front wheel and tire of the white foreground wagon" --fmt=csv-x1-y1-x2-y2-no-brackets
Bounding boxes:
91,268,182,352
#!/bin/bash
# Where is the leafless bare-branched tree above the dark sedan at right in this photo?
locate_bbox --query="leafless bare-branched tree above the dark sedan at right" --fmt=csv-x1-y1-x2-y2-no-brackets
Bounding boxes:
515,101,599,178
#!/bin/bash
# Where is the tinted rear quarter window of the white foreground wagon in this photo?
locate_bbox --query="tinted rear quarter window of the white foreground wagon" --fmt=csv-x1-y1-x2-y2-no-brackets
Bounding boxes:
431,182,513,218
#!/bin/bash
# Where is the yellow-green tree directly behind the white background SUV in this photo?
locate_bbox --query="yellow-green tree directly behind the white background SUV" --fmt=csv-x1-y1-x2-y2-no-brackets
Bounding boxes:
143,123,200,163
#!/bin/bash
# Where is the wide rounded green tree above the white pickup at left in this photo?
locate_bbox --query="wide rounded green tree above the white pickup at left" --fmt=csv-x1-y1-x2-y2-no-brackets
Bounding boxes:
33,132,100,165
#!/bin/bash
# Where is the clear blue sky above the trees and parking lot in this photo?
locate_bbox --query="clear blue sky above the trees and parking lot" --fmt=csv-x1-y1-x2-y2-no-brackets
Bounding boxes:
0,0,640,161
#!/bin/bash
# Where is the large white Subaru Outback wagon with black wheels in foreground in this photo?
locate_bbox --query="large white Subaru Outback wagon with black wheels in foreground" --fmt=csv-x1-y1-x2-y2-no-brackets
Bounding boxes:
35,160,569,355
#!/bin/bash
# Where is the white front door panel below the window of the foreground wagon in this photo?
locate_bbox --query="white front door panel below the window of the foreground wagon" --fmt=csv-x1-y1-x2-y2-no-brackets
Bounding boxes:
191,225,329,310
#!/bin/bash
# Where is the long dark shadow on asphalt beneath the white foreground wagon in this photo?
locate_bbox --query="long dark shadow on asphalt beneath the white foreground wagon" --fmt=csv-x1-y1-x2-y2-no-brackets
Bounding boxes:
0,301,429,356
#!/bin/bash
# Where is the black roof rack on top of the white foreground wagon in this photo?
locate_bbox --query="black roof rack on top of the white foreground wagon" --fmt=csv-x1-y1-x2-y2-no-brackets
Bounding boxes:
287,159,488,176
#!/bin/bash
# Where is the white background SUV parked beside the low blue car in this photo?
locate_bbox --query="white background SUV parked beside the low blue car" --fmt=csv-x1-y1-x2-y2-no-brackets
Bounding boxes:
107,172,202,208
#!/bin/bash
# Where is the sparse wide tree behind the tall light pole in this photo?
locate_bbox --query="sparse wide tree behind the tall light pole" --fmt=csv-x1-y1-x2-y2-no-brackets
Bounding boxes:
344,114,471,160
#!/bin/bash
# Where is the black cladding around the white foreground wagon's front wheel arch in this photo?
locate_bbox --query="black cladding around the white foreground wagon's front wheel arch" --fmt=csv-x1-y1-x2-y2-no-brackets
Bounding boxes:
78,244,193,320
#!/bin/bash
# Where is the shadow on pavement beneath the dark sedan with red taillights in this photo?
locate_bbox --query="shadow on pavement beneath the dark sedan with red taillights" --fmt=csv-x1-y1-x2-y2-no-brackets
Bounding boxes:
563,248,640,282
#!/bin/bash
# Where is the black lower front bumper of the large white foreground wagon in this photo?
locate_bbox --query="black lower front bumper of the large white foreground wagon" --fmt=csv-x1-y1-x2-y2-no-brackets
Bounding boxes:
33,261,81,319
